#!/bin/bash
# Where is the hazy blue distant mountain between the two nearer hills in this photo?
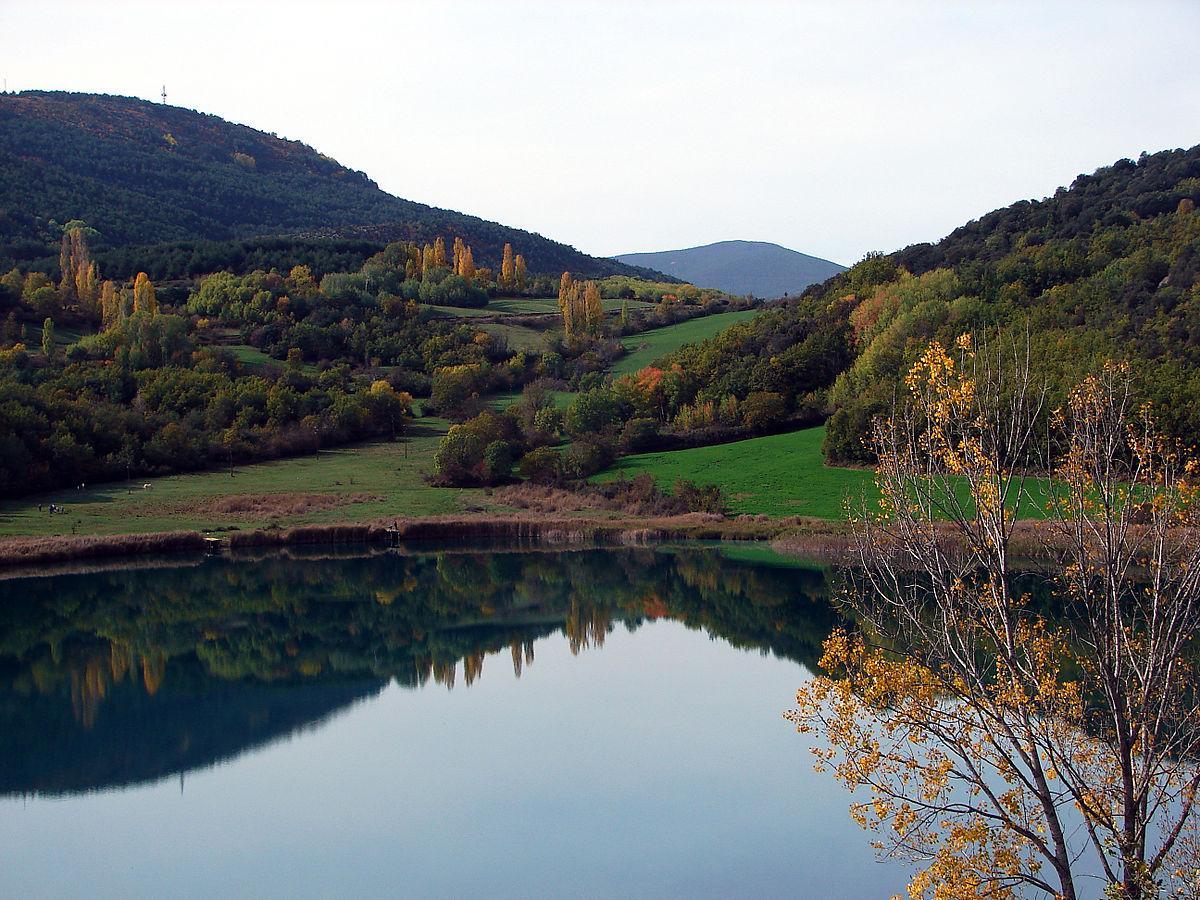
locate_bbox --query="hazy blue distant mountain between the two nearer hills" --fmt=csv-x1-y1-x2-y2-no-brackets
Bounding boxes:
613,241,846,299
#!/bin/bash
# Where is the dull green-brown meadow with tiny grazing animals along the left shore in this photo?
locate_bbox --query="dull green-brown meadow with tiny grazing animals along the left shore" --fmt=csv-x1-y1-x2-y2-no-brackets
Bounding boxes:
0,419,482,535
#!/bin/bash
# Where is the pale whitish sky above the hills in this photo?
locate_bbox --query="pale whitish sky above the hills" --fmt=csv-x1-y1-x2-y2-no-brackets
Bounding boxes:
0,0,1200,264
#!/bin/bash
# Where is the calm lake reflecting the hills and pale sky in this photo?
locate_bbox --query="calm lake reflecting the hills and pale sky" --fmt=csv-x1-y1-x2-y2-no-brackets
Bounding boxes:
0,546,906,898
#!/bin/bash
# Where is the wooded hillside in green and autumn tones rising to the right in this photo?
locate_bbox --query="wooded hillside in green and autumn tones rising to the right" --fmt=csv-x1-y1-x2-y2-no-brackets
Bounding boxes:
638,146,1200,461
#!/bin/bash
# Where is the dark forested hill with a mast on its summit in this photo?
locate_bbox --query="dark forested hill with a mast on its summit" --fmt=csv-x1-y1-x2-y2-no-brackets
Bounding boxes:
0,91,657,275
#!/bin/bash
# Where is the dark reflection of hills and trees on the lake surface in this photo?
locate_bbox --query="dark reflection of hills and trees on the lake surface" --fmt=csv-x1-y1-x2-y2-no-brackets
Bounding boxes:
0,547,834,796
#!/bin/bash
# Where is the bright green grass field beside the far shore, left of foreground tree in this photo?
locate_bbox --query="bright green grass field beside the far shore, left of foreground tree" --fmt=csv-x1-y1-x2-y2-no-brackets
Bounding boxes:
599,427,875,518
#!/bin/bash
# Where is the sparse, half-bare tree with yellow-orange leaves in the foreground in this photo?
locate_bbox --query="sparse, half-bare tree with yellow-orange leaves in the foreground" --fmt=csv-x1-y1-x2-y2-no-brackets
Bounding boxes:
788,337,1200,900
